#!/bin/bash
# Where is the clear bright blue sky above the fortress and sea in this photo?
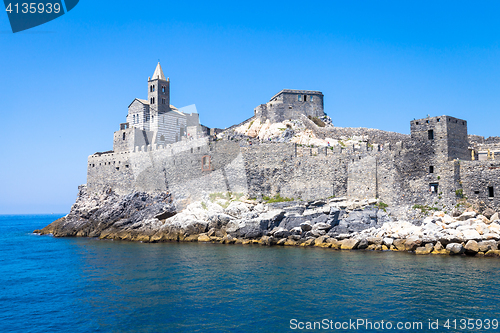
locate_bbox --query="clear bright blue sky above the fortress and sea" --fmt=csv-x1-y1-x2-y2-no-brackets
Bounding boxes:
0,0,500,214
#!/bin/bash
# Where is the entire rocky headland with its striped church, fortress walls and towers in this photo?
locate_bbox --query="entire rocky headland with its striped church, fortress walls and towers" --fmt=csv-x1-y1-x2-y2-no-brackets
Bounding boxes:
39,65,500,255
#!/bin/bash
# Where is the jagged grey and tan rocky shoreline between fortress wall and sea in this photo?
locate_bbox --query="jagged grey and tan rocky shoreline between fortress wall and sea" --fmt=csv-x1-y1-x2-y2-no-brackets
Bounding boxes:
34,185,500,256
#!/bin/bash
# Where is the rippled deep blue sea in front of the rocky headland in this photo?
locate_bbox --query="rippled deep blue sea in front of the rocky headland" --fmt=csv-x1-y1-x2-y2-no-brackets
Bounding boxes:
0,215,500,332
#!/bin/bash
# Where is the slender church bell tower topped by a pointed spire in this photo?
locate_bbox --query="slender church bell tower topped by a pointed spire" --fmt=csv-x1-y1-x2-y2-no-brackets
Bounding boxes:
148,62,170,116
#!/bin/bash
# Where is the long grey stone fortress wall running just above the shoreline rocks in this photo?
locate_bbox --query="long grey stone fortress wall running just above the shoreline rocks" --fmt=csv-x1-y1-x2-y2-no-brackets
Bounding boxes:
88,138,500,208
